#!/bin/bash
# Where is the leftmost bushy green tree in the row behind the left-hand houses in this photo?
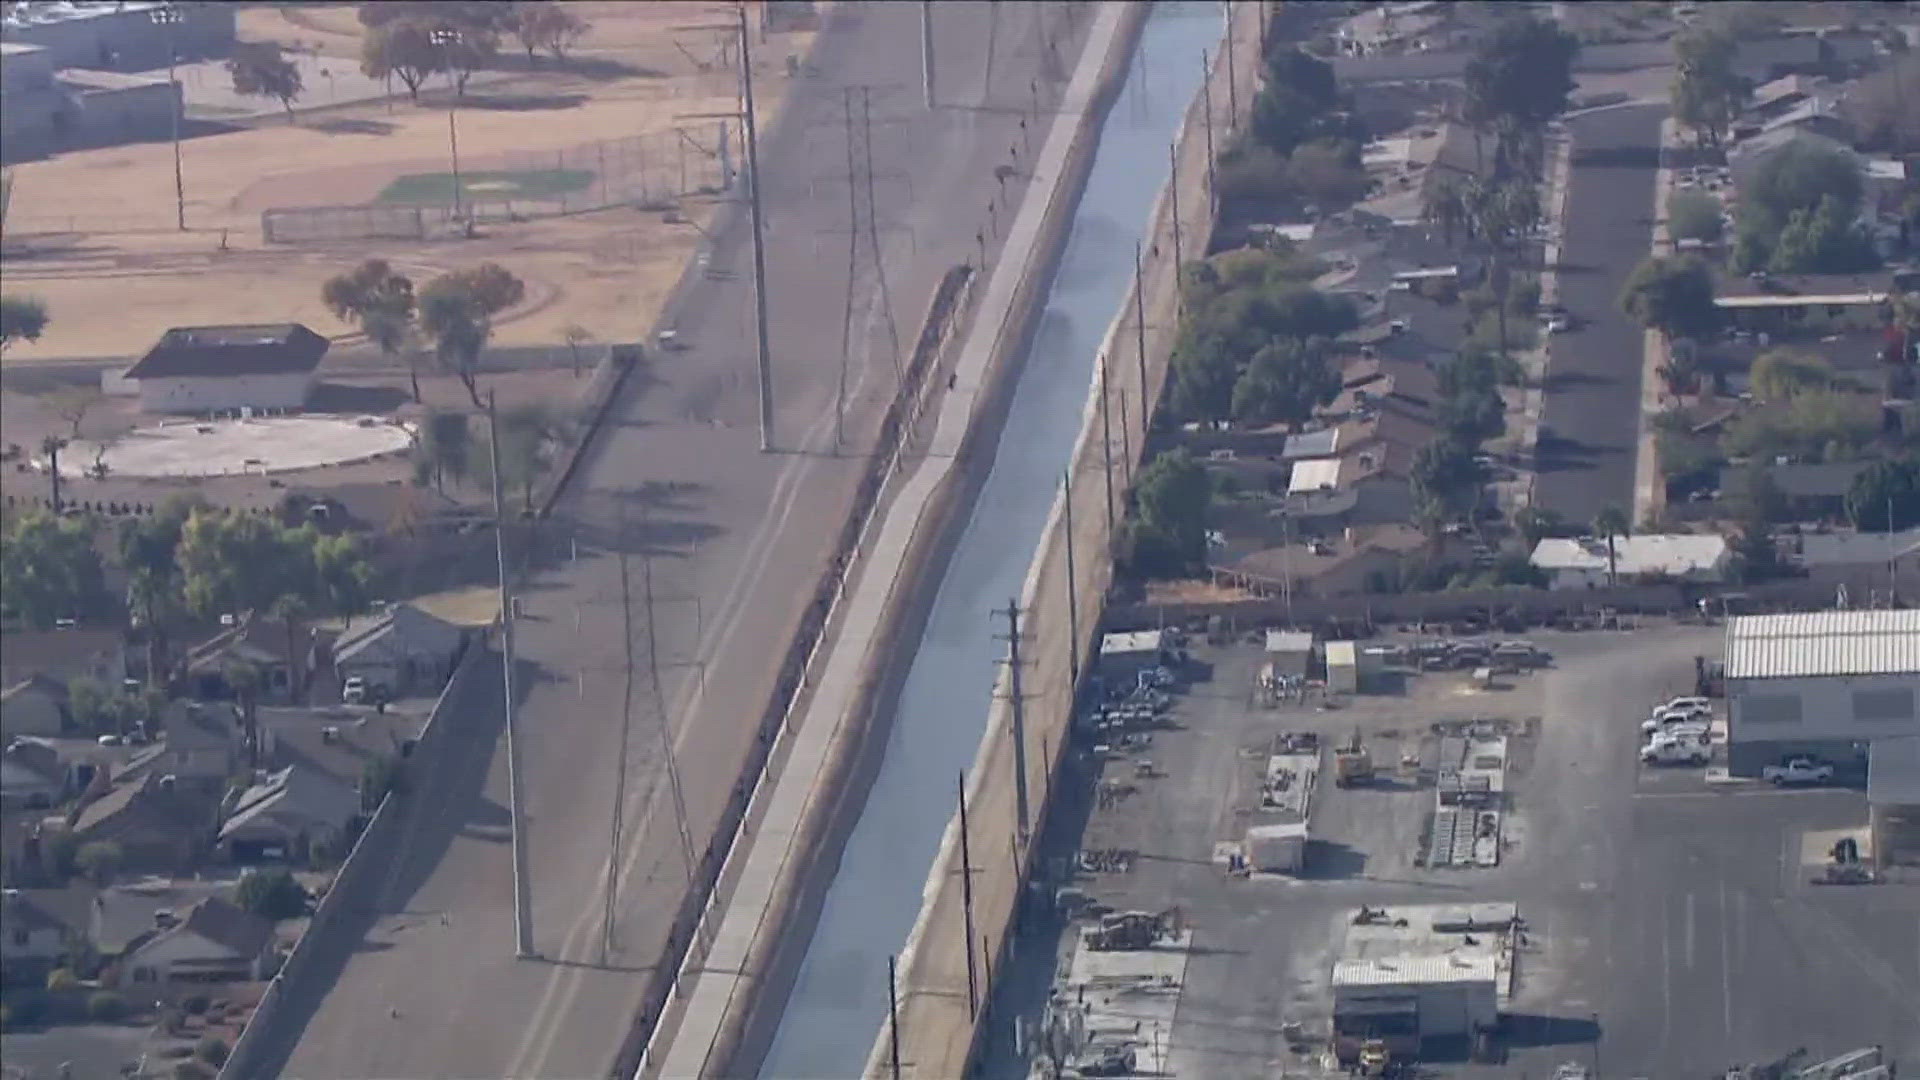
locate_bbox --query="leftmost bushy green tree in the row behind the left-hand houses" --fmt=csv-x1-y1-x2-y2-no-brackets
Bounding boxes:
0,511,109,630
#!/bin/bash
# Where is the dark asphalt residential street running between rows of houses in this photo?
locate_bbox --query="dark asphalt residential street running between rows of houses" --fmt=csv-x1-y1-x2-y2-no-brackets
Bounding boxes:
1534,106,1665,523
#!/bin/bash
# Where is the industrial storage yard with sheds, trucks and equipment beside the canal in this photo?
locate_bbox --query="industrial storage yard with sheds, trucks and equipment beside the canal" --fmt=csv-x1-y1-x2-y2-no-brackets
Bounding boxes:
998,611,1920,1076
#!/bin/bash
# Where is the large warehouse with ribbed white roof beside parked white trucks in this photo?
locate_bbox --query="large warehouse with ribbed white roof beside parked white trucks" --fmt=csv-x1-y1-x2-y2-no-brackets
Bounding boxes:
1726,611,1920,776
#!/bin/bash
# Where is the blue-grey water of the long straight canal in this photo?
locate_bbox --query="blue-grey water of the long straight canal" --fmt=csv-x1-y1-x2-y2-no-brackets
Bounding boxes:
760,4,1221,1078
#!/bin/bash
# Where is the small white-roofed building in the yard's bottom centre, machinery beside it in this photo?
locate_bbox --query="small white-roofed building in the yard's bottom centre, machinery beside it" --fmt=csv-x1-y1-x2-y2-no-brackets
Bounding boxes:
1332,903,1521,1065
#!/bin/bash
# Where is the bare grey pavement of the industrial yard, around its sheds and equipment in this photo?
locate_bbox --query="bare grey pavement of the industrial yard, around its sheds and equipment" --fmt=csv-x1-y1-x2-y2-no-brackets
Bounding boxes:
998,623,1920,1078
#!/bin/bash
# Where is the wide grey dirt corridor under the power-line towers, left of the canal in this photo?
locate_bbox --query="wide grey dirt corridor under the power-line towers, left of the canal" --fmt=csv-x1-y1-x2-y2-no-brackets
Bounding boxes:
259,2,1098,1078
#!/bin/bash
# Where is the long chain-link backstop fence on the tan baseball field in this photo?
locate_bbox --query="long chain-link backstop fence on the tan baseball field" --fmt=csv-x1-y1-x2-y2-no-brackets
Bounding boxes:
259,121,743,244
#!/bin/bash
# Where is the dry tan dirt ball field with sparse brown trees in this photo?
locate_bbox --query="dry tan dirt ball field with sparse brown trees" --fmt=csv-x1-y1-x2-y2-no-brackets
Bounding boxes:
4,2,812,361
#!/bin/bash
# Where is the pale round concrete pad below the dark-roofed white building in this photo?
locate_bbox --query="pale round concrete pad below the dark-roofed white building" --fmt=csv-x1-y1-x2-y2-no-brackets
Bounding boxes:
60,415,413,477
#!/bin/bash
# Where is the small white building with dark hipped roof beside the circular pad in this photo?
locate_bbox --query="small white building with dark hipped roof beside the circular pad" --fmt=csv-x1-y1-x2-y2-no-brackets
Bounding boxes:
125,323,328,413
